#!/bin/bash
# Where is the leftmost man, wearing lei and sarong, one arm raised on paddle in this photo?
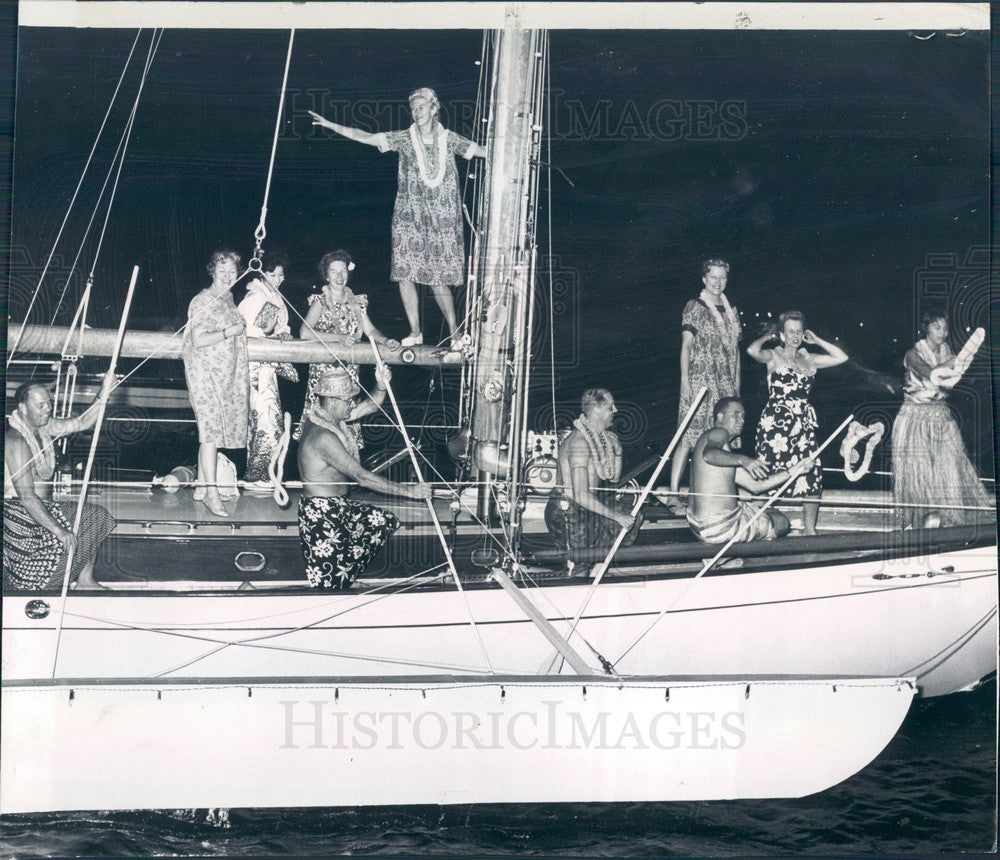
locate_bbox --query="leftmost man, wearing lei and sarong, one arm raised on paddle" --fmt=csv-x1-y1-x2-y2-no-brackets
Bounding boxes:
3,372,115,591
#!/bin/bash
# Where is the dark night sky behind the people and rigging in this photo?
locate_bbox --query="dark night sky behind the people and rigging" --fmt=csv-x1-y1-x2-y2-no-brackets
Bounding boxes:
11,29,992,478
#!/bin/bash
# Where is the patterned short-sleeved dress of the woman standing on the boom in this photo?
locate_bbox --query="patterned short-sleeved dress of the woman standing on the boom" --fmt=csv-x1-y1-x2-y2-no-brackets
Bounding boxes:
379,130,473,286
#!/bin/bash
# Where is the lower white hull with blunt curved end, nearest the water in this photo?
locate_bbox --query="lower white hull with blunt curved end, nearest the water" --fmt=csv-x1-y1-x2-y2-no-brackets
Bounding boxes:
0,678,914,814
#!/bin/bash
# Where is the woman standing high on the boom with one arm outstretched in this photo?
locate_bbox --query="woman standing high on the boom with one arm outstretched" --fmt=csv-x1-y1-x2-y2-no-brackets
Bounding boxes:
309,87,486,348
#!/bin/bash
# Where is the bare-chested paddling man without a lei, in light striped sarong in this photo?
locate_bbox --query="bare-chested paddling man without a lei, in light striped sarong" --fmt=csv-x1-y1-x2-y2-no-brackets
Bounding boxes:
687,397,813,544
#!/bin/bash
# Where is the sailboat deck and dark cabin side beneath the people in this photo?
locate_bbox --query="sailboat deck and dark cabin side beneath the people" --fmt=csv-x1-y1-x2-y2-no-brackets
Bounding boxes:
29,486,984,590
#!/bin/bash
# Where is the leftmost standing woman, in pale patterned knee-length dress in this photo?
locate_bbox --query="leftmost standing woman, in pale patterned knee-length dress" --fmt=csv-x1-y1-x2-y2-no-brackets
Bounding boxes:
183,250,250,517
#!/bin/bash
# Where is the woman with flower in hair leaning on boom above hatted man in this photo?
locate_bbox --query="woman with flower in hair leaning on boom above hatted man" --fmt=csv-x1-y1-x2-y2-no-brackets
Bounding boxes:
299,248,399,447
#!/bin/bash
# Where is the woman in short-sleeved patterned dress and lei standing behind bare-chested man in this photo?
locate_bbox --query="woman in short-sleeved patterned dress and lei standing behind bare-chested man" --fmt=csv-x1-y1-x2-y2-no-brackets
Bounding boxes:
670,260,742,509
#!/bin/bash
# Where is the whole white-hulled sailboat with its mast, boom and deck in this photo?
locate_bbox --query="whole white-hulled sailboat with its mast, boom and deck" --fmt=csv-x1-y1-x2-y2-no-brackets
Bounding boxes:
0,21,997,813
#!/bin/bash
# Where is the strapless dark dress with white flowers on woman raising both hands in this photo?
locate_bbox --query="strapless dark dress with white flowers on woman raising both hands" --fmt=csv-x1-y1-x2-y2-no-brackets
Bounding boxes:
756,367,823,496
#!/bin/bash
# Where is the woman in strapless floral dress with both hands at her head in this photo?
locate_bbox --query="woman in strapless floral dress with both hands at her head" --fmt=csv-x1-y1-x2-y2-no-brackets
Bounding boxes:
747,311,847,535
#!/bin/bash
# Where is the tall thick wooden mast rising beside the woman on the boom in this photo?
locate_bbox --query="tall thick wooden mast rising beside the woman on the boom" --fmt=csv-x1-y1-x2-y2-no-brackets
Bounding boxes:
471,26,545,528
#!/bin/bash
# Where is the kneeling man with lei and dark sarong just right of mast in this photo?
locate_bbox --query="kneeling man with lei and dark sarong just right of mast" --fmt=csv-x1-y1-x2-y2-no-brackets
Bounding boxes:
545,388,641,576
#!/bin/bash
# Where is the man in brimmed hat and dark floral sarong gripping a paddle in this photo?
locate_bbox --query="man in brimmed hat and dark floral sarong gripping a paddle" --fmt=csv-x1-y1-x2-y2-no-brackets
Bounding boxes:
299,367,431,588
